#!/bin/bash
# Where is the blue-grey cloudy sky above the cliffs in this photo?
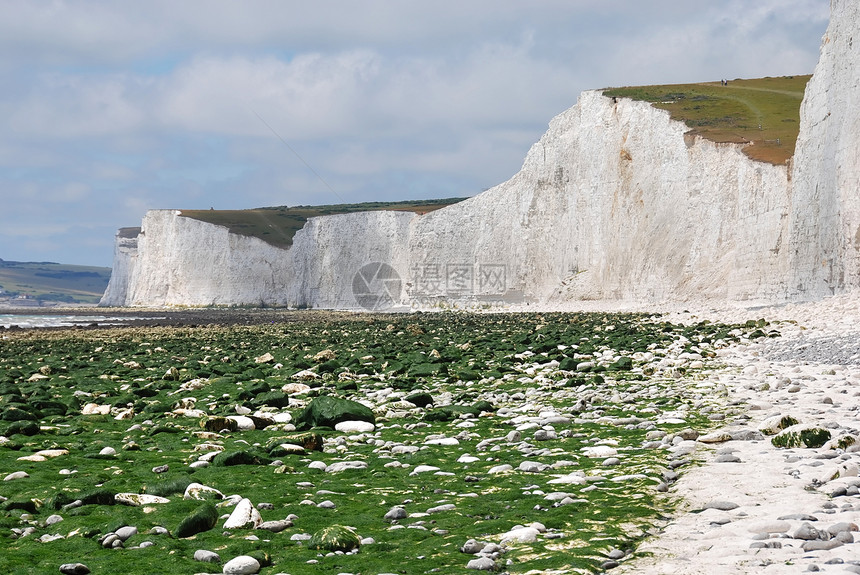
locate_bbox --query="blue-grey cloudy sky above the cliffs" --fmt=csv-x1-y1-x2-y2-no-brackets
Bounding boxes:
0,0,830,266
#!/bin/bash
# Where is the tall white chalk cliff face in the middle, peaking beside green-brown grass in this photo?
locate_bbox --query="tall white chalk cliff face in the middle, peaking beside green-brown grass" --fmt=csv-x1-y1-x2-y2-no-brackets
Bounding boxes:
410,92,788,301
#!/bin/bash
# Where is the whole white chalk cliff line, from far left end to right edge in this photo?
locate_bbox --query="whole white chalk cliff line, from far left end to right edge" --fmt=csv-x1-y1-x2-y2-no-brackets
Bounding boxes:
102,0,860,308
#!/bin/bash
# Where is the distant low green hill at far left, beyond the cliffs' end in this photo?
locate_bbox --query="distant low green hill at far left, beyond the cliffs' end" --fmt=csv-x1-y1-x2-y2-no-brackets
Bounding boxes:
0,259,110,304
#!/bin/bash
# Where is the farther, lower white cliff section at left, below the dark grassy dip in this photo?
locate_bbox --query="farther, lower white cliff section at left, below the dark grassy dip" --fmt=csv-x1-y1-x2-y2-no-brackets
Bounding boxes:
101,210,413,308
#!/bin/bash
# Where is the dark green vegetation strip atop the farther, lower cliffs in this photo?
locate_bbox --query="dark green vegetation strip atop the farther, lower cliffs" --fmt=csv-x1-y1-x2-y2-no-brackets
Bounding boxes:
182,198,466,248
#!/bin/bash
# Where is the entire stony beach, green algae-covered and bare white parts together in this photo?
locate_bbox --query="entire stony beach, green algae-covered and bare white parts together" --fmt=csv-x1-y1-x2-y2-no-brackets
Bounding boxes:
0,297,860,574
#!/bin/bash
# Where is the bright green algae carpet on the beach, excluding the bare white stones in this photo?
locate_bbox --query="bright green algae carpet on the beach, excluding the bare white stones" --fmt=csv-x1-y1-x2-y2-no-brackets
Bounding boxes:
0,314,761,575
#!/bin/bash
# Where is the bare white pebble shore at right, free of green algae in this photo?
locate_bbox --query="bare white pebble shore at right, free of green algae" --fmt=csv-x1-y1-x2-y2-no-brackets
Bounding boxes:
617,294,860,575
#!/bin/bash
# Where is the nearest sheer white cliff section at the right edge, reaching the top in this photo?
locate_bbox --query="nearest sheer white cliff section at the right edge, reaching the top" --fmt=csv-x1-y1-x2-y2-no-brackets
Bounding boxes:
789,0,860,299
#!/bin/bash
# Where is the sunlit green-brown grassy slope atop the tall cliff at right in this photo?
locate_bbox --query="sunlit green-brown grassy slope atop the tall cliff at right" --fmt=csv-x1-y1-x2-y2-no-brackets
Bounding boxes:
603,75,811,165
